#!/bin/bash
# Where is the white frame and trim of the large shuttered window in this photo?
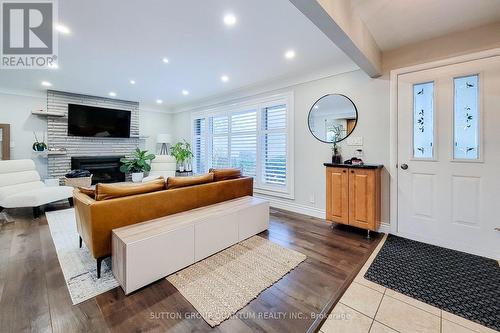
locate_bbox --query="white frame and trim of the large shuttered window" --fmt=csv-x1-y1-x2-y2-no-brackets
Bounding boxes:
191,91,295,199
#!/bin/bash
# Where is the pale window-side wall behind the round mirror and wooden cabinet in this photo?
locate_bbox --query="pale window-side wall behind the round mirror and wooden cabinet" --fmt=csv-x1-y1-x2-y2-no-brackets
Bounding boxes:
173,70,389,223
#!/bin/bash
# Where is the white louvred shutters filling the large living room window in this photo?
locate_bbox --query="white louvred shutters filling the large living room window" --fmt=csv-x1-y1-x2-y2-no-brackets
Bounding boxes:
193,94,293,198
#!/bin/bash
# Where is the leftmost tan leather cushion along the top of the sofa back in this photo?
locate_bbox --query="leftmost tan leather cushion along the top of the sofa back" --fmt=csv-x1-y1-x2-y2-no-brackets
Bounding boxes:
95,178,165,201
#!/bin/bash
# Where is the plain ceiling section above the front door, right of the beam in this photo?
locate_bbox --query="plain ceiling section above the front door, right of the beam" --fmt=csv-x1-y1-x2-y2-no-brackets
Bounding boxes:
351,0,500,51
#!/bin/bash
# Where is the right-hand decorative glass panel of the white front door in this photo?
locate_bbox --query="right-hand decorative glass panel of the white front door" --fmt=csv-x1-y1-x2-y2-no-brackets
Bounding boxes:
453,75,479,160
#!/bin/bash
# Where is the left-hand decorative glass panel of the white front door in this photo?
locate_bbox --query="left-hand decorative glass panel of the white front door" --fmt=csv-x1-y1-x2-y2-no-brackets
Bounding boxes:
413,82,434,159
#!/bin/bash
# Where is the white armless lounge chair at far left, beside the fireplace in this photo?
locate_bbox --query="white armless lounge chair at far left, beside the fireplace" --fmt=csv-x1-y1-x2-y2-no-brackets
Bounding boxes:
0,160,73,218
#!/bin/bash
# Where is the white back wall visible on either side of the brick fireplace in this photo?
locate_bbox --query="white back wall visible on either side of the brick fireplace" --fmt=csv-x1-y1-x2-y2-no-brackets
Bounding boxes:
0,93,173,178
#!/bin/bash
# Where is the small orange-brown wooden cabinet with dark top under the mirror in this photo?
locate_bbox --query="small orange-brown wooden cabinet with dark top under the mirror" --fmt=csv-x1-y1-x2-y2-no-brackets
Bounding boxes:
325,163,382,232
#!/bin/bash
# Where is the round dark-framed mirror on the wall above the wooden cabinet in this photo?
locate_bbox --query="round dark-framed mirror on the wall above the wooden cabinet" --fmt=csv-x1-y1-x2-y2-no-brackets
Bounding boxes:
307,94,358,143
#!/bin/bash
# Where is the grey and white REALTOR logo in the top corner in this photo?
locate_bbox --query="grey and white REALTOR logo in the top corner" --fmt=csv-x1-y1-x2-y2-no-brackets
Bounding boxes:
0,0,57,69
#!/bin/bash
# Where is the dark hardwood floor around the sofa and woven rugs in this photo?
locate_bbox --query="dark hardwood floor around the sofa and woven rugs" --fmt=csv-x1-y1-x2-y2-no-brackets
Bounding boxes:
0,205,380,333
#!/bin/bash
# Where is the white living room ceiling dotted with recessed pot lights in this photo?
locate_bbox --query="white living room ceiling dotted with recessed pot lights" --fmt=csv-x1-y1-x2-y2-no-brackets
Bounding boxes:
0,0,357,109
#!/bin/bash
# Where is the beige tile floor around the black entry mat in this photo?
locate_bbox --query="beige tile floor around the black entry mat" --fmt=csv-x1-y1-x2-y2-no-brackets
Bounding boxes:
320,237,496,333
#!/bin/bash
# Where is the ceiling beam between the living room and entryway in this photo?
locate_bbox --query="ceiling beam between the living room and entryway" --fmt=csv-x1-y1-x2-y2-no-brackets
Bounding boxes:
289,0,382,77
